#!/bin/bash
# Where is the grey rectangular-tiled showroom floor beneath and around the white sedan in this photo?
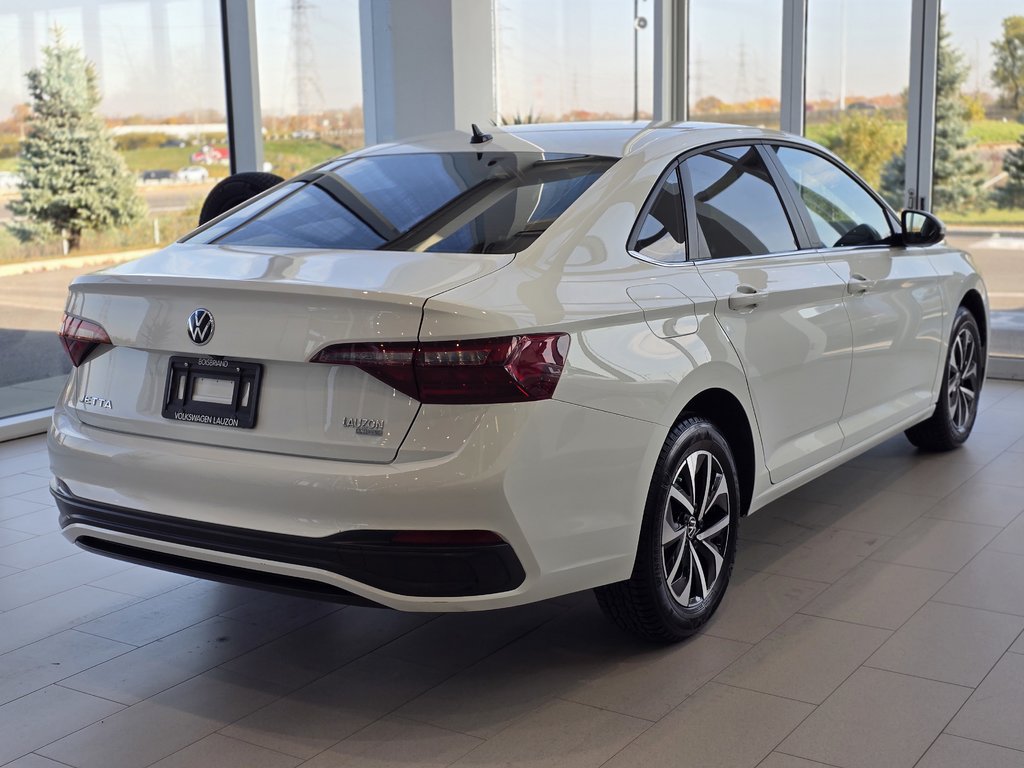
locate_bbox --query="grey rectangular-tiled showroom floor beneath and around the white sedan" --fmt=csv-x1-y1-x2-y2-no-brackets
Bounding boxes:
0,382,1024,768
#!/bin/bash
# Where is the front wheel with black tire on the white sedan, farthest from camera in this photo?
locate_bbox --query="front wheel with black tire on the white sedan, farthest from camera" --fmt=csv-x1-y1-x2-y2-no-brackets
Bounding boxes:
905,306,985,452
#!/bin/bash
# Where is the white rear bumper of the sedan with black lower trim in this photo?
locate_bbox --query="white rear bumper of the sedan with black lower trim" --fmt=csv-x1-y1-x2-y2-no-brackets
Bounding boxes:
49,400,664,611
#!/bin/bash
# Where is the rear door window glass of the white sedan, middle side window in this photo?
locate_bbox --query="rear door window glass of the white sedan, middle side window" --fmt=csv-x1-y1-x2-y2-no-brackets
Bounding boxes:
682,146,797,258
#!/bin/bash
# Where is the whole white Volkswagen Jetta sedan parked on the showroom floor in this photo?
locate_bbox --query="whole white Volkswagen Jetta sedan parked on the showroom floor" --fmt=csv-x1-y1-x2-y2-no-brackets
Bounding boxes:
49,124,988,640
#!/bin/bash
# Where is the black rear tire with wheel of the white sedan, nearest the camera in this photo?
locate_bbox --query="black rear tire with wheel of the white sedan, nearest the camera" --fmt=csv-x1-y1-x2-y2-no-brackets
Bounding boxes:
595,416,740,642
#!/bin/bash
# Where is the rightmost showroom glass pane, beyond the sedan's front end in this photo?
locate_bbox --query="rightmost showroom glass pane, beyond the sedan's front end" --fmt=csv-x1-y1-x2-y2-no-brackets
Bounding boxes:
933,0,1024,357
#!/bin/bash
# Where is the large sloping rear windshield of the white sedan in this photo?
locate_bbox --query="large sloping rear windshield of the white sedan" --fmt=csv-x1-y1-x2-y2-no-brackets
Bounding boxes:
186,152,615,253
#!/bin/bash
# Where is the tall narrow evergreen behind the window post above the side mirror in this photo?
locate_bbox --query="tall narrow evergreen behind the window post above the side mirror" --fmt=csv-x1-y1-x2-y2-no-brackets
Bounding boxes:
882,15,982,211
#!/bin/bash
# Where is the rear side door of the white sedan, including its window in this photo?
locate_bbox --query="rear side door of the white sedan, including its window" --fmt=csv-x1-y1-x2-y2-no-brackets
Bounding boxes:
681,144,851,482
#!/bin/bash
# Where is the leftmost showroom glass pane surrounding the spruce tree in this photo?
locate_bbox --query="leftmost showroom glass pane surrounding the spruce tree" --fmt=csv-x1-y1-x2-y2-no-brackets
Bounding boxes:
0,0,228,423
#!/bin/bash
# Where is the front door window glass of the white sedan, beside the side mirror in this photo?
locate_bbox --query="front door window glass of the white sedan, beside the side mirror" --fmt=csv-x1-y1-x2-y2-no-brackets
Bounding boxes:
772,146,892,248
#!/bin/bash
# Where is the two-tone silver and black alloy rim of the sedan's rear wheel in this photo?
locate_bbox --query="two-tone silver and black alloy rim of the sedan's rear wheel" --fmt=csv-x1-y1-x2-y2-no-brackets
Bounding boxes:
662,450,730,608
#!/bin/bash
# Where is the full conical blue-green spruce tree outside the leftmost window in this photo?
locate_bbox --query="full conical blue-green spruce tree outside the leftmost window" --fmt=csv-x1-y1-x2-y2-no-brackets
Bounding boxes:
10,29,144,249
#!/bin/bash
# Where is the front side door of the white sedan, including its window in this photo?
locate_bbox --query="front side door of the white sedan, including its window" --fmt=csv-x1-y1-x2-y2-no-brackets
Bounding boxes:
772,145,943,446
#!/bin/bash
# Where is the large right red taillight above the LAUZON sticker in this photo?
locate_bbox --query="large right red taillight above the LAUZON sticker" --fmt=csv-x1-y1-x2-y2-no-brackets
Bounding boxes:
312,334,569,403
